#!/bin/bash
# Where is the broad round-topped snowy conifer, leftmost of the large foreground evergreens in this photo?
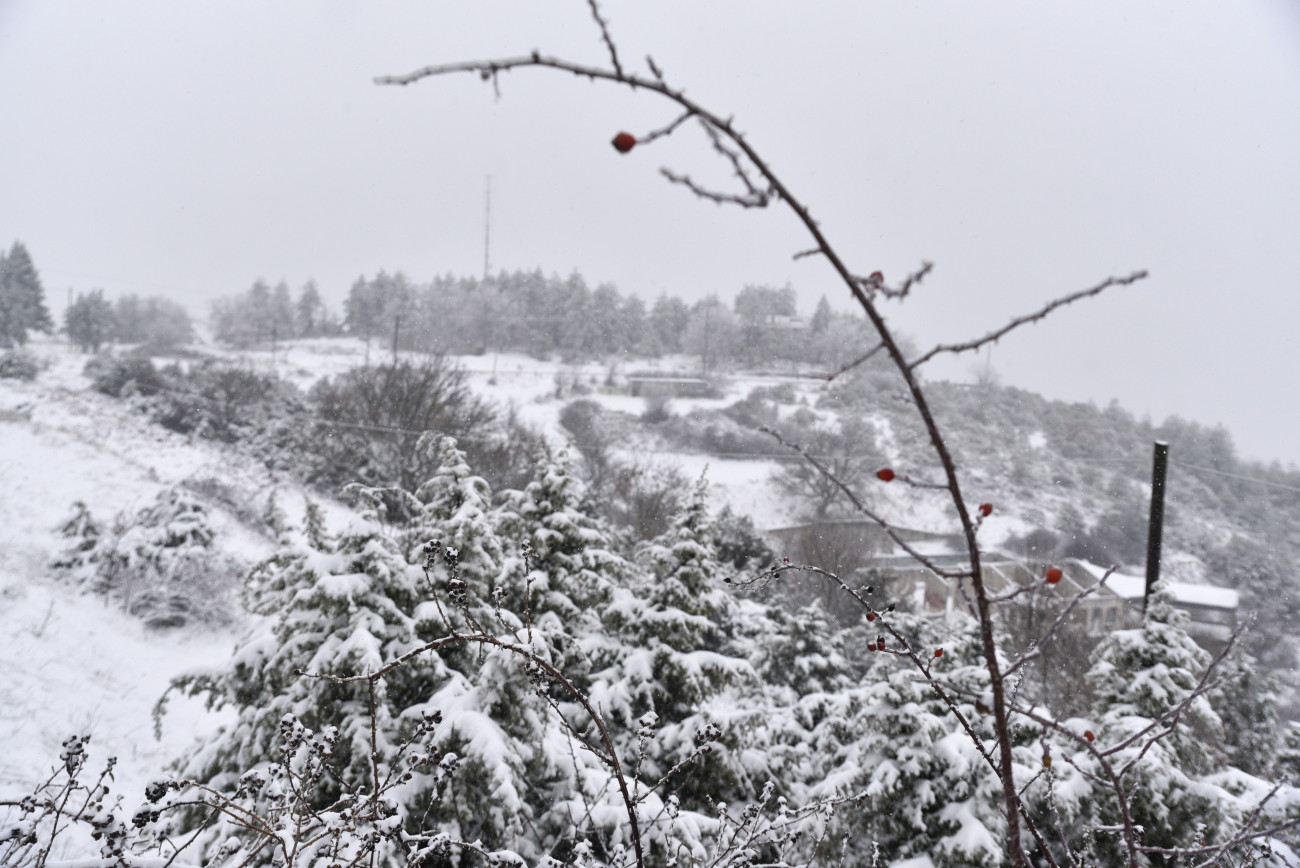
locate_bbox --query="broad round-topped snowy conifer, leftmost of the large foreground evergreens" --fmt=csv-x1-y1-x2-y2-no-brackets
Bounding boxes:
173,501,447,858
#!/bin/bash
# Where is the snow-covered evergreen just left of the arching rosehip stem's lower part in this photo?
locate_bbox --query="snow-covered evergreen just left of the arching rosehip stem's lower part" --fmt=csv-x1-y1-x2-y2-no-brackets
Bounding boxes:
790,613,1003,867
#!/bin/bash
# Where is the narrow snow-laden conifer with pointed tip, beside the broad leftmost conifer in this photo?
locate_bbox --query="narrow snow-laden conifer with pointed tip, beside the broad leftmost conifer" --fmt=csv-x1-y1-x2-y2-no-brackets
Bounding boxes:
403,437,576,859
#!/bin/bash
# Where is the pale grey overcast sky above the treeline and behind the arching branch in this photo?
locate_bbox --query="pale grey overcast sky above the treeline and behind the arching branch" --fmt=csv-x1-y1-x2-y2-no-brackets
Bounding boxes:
0,0,1300,463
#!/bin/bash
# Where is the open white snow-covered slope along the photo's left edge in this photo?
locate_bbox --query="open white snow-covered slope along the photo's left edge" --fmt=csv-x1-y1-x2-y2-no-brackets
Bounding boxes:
0,344,293,798
